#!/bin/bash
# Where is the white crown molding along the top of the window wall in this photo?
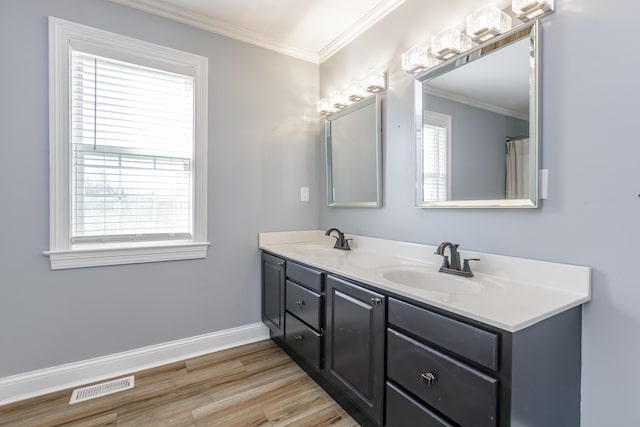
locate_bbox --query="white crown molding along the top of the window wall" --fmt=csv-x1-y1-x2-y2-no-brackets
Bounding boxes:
110,0,319,64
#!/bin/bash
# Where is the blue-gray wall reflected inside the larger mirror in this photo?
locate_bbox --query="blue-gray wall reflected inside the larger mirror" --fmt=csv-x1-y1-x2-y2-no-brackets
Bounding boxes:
422,94,529,200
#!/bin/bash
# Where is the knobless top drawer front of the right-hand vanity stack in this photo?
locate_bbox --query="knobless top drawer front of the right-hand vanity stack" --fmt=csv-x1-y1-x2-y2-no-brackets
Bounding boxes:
389,298,498,371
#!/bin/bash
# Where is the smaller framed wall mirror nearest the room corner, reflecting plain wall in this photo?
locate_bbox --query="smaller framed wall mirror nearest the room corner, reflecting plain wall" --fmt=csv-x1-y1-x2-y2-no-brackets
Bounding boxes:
325,95,382,208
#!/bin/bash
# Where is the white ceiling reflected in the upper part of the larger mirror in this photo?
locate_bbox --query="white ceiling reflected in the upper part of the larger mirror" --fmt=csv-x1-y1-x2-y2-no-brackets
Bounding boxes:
425,38,530,117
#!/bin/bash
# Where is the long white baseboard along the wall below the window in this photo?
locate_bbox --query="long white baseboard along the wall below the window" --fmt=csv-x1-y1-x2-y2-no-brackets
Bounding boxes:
0,323,269,405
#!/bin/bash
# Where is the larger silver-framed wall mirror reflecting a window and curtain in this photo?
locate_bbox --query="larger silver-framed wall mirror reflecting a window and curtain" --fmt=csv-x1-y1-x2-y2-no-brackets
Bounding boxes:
415,21,540,208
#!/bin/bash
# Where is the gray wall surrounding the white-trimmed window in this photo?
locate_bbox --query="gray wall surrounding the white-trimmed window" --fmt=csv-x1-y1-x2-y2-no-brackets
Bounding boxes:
0,0,318,377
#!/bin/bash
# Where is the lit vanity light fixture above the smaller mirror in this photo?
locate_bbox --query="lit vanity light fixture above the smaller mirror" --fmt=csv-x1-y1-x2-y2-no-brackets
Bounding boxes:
317,70,387,116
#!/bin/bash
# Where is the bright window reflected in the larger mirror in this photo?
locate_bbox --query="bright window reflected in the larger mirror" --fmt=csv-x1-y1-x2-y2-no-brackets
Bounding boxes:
422,111,451,202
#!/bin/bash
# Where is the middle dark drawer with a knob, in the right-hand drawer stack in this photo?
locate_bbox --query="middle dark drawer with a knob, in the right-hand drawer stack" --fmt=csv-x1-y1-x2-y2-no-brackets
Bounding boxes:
387,329,498,427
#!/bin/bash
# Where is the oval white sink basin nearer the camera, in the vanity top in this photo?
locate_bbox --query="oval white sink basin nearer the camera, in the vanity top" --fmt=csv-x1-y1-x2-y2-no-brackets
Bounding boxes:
377,265,482,294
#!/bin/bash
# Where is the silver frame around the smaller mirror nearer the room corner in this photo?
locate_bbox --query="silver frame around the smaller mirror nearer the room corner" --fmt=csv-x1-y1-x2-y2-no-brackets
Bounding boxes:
325,94,382,208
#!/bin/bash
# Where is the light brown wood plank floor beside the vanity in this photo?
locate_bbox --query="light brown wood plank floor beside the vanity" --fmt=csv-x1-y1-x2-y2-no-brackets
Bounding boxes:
0,340,358,427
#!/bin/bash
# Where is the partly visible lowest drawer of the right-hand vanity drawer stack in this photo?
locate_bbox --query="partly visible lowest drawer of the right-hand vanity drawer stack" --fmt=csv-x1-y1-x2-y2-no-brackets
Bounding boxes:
386,383,453,427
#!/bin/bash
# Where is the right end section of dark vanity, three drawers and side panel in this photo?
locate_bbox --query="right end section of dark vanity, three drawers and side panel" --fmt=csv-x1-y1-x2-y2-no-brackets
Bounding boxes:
386,298,581,427
